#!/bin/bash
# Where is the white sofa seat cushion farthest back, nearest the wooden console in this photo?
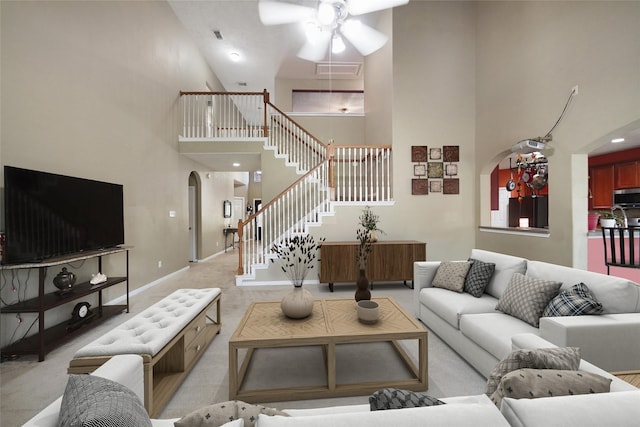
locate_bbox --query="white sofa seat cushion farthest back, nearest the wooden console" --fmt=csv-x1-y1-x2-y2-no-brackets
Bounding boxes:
420,288,498,329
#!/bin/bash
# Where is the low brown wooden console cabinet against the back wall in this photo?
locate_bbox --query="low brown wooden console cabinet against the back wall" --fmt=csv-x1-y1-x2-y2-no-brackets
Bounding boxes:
320,240,427,292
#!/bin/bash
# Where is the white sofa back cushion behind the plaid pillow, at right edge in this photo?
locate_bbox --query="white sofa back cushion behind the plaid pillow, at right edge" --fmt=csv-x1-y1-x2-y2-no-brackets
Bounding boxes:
527,261,640,314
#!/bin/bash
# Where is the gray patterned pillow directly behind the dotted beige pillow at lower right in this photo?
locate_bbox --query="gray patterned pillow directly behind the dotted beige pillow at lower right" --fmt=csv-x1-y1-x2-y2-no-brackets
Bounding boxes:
485,347,580,397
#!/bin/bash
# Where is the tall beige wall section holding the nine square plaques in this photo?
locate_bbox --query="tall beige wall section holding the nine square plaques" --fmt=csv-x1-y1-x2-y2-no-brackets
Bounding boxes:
388,2,477,260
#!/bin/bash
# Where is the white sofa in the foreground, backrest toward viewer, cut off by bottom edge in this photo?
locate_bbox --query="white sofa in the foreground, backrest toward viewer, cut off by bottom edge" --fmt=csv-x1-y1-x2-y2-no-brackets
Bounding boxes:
25,334,640,427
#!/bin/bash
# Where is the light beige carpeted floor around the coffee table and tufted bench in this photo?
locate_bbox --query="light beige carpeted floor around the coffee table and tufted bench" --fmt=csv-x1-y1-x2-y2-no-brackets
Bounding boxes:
0,251,486,427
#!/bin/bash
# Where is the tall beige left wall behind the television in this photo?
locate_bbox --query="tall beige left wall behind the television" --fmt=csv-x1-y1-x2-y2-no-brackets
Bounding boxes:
0,1,222,345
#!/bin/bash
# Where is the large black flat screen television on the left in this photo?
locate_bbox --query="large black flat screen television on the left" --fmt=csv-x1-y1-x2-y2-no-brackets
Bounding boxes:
2,166,124,264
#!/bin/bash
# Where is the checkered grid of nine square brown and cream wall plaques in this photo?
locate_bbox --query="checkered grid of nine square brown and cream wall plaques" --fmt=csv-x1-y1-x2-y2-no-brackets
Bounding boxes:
411,145,460,196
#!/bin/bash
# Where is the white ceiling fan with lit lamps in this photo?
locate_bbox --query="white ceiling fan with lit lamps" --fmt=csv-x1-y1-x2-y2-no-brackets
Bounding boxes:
258,0,409,61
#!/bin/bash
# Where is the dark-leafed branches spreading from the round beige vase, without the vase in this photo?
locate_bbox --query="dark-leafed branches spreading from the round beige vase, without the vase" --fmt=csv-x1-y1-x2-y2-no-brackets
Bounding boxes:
271,234,325,288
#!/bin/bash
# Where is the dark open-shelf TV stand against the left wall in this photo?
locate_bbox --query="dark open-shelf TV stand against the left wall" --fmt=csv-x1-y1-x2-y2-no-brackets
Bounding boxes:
0,247,131,362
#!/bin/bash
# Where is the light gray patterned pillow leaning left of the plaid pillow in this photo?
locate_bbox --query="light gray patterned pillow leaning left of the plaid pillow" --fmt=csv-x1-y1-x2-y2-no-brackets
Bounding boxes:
496,273,562,327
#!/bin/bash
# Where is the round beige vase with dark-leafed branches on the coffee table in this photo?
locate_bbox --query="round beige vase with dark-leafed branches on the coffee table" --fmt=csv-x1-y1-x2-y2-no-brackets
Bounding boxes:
271,234,325,319
